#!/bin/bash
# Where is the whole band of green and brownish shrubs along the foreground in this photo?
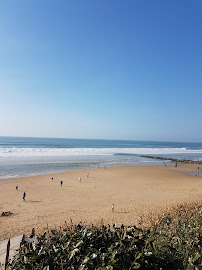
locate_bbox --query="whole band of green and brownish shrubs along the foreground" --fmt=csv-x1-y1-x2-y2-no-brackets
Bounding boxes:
10,203,202,270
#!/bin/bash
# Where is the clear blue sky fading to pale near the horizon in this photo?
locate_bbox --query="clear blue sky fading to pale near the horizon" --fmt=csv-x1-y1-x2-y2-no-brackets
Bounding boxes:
0,0,202,142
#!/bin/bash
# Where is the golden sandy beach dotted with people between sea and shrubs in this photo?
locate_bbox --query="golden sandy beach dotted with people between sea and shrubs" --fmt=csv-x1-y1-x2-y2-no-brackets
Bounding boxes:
0,164,202,240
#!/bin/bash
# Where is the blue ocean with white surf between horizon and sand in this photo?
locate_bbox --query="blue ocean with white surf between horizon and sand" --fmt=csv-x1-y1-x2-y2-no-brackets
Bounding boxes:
0,137,202,179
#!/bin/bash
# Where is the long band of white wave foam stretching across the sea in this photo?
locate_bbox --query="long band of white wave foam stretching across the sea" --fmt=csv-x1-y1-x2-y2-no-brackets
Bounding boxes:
0,148,202,158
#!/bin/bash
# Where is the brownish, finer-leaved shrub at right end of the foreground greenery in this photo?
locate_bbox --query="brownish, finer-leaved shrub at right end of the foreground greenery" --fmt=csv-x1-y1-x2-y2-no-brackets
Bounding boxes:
150,203,202,269
